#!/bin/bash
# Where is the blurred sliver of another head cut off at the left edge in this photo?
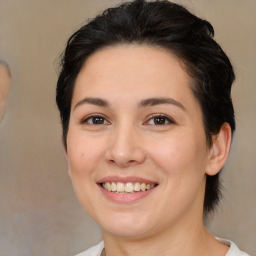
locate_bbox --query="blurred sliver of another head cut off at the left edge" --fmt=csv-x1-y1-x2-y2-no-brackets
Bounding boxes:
0,60,11,120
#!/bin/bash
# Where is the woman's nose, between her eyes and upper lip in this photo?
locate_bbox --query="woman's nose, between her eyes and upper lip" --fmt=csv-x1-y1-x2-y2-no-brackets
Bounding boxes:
105,125,146,168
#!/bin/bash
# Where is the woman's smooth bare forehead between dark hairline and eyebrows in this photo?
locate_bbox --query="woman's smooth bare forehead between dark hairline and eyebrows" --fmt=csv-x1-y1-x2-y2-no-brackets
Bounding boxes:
73,45,195,104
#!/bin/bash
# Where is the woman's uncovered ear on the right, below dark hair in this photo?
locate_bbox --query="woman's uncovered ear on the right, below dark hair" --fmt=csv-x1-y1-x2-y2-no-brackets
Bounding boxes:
205,123,232,176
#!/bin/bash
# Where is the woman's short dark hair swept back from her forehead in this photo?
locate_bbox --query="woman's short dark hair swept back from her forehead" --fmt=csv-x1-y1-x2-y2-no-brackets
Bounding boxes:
56,0,235,217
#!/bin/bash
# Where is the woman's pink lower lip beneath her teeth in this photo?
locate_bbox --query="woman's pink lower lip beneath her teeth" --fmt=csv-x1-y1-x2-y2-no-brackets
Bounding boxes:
98,185,156,203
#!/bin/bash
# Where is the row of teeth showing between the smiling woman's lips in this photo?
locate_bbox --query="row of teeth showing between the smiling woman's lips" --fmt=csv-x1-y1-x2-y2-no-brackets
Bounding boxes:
100,182,157,194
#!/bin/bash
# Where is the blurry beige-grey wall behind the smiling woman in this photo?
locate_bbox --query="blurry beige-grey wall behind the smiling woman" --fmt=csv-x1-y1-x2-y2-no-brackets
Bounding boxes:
0,0,256,256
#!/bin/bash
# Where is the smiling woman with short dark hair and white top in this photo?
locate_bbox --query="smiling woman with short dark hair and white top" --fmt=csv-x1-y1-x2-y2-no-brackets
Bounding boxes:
57,0,247,256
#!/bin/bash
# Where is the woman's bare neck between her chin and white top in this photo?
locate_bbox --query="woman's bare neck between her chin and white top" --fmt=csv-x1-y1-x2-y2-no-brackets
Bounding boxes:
102,216,221,256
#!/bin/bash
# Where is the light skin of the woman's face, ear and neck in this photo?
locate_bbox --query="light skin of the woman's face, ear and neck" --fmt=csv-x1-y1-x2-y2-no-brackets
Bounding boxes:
66,45,231,256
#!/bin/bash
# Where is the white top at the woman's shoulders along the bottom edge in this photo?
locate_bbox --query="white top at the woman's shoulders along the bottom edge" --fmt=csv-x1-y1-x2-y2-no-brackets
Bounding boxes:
76,238,249,256
